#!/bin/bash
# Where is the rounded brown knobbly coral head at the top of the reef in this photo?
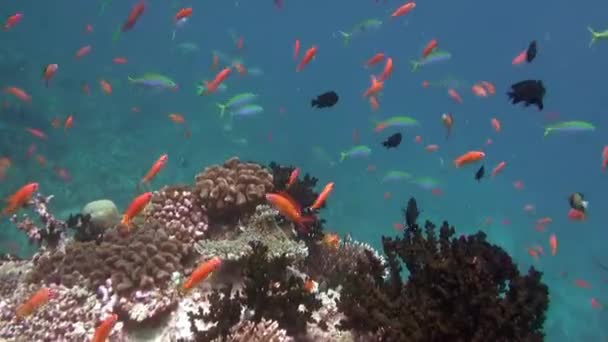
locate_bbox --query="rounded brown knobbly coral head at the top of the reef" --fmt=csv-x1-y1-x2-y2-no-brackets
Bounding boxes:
195,157,273,222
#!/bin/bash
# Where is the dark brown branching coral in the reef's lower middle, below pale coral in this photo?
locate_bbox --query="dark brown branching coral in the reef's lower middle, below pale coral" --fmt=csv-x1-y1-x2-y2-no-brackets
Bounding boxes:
243,243,321,336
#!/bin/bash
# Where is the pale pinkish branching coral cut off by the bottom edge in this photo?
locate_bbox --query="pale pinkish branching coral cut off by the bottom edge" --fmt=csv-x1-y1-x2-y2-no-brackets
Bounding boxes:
220,318,294,342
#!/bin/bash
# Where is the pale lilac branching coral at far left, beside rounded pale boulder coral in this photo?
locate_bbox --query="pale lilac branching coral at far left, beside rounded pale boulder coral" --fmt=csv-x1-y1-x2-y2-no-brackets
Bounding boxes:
10,193,67,248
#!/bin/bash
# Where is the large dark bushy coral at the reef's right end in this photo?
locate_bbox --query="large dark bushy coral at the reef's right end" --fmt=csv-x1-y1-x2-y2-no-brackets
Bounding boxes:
338,198,548,342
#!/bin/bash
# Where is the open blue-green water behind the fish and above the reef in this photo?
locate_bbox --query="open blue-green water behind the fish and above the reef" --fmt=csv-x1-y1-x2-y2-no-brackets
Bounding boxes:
0,0,608,341
